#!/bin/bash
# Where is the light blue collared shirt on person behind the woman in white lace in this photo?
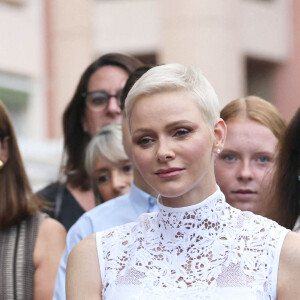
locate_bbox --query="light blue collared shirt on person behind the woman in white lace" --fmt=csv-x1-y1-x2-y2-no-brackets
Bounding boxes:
53,183,158,300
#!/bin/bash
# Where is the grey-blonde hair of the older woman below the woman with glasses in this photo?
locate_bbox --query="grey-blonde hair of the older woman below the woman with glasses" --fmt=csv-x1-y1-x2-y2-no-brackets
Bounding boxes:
85,124,128,177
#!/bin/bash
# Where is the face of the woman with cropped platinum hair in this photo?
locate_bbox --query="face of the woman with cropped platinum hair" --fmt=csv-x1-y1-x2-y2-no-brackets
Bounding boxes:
130,92,219,206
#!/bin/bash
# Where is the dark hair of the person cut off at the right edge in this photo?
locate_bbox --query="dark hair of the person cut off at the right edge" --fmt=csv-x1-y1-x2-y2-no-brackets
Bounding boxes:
272,108,300,229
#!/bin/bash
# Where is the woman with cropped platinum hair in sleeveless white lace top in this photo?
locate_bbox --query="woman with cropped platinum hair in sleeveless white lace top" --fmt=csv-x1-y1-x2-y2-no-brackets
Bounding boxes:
66,64,300,300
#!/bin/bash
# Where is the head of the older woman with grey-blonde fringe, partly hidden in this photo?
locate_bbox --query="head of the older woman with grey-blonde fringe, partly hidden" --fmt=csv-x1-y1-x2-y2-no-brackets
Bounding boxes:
85,124,133,203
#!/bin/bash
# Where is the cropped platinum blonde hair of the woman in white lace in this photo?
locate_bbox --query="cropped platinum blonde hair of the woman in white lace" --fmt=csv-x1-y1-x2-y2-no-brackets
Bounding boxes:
125,64,220,129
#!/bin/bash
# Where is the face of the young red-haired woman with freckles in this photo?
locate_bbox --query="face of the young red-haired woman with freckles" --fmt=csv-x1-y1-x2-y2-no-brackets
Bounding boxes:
215,118,278,215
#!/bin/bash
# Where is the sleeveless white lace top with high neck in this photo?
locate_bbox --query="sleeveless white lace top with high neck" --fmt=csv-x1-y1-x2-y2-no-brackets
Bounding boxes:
96,190,288,300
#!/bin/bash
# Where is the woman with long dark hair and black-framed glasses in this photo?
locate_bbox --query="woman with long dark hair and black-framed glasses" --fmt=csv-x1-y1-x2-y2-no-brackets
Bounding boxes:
38,53,142,230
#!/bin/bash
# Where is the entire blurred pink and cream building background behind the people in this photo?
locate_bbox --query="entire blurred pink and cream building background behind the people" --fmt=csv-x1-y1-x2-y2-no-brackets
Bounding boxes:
0,0,300,191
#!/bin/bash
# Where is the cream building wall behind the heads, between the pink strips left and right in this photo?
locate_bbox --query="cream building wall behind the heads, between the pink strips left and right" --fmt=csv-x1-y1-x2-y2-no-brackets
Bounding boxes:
43,0,291,136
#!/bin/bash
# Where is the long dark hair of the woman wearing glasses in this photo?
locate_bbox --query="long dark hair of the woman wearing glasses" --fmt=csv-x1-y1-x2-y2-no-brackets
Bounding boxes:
61,53,142,190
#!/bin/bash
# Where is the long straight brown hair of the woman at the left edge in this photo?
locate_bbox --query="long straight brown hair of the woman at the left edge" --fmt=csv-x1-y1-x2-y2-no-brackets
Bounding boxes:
0,101,43,228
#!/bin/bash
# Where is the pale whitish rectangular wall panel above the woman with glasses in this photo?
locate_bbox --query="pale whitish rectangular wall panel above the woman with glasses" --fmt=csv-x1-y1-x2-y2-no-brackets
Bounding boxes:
92,0,160,54
